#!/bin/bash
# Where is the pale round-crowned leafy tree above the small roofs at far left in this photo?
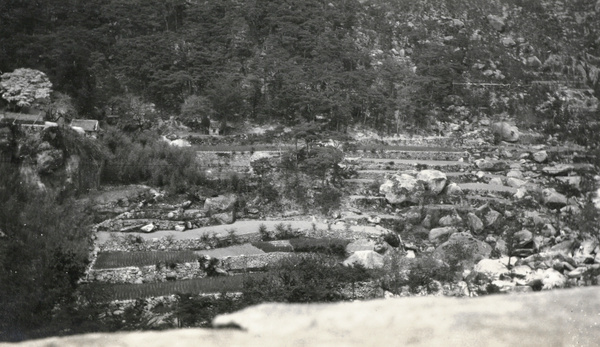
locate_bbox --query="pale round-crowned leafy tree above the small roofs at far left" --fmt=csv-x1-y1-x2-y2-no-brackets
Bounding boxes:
0,68,52,109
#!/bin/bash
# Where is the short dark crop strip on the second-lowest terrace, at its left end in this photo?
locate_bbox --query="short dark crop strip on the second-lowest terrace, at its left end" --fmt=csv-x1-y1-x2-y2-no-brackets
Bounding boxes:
94,251,198,269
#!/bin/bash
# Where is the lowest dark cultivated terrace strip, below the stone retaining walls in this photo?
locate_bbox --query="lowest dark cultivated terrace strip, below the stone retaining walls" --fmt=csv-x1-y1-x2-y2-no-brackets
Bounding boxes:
102,274,264,301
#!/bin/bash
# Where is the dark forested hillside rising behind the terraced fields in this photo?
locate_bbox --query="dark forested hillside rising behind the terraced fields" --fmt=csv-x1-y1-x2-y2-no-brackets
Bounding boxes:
0,0,600,131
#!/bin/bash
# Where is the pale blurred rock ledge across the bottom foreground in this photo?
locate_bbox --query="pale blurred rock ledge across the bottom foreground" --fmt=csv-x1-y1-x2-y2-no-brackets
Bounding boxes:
9,287,600,347
